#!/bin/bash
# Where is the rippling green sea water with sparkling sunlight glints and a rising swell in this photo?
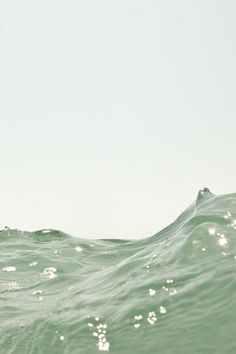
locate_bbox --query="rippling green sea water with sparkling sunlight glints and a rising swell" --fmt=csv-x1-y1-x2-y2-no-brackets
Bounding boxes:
0,189,236,354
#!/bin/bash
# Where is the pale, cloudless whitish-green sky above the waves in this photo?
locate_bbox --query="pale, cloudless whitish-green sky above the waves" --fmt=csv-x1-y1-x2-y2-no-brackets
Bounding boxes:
0,0,236,238
